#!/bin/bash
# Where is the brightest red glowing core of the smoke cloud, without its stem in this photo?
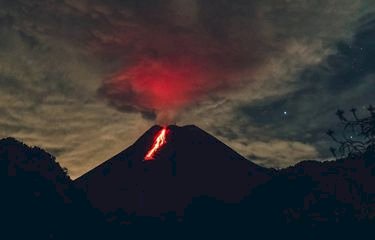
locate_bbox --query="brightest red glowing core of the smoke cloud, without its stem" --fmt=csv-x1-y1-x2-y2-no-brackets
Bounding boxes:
108,58,226,113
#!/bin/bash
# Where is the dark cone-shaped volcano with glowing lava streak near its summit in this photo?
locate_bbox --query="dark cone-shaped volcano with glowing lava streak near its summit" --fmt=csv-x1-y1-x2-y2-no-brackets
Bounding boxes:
75,125,274,220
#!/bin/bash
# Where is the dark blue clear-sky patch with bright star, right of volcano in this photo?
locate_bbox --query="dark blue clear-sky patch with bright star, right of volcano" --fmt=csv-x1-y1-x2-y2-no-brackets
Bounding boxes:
238,15,375,165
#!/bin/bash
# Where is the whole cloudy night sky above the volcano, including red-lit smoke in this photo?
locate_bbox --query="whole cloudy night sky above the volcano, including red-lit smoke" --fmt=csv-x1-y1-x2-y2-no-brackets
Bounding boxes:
0,0,375,178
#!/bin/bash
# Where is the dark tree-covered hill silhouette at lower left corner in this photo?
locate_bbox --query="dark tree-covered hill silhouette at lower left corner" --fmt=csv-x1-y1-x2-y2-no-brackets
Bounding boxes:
0,138,100,239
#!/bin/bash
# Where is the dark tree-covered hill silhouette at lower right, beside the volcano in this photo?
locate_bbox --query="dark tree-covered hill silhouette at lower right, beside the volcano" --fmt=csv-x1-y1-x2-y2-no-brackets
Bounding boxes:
245,152,375,236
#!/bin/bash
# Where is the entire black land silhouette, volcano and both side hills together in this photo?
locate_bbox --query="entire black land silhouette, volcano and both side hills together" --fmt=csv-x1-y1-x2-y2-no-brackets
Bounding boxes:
0,125,375,239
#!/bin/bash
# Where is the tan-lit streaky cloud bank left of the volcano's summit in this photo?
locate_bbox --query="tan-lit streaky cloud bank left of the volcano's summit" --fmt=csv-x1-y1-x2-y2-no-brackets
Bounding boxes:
0,19,149,178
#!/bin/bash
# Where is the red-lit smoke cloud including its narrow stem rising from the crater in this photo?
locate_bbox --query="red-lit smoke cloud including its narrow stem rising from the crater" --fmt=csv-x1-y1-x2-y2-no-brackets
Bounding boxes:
101,50,250,124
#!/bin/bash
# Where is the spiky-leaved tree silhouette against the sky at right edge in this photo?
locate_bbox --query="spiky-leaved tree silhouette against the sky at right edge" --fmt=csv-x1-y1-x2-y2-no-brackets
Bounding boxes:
326,105,375,159
